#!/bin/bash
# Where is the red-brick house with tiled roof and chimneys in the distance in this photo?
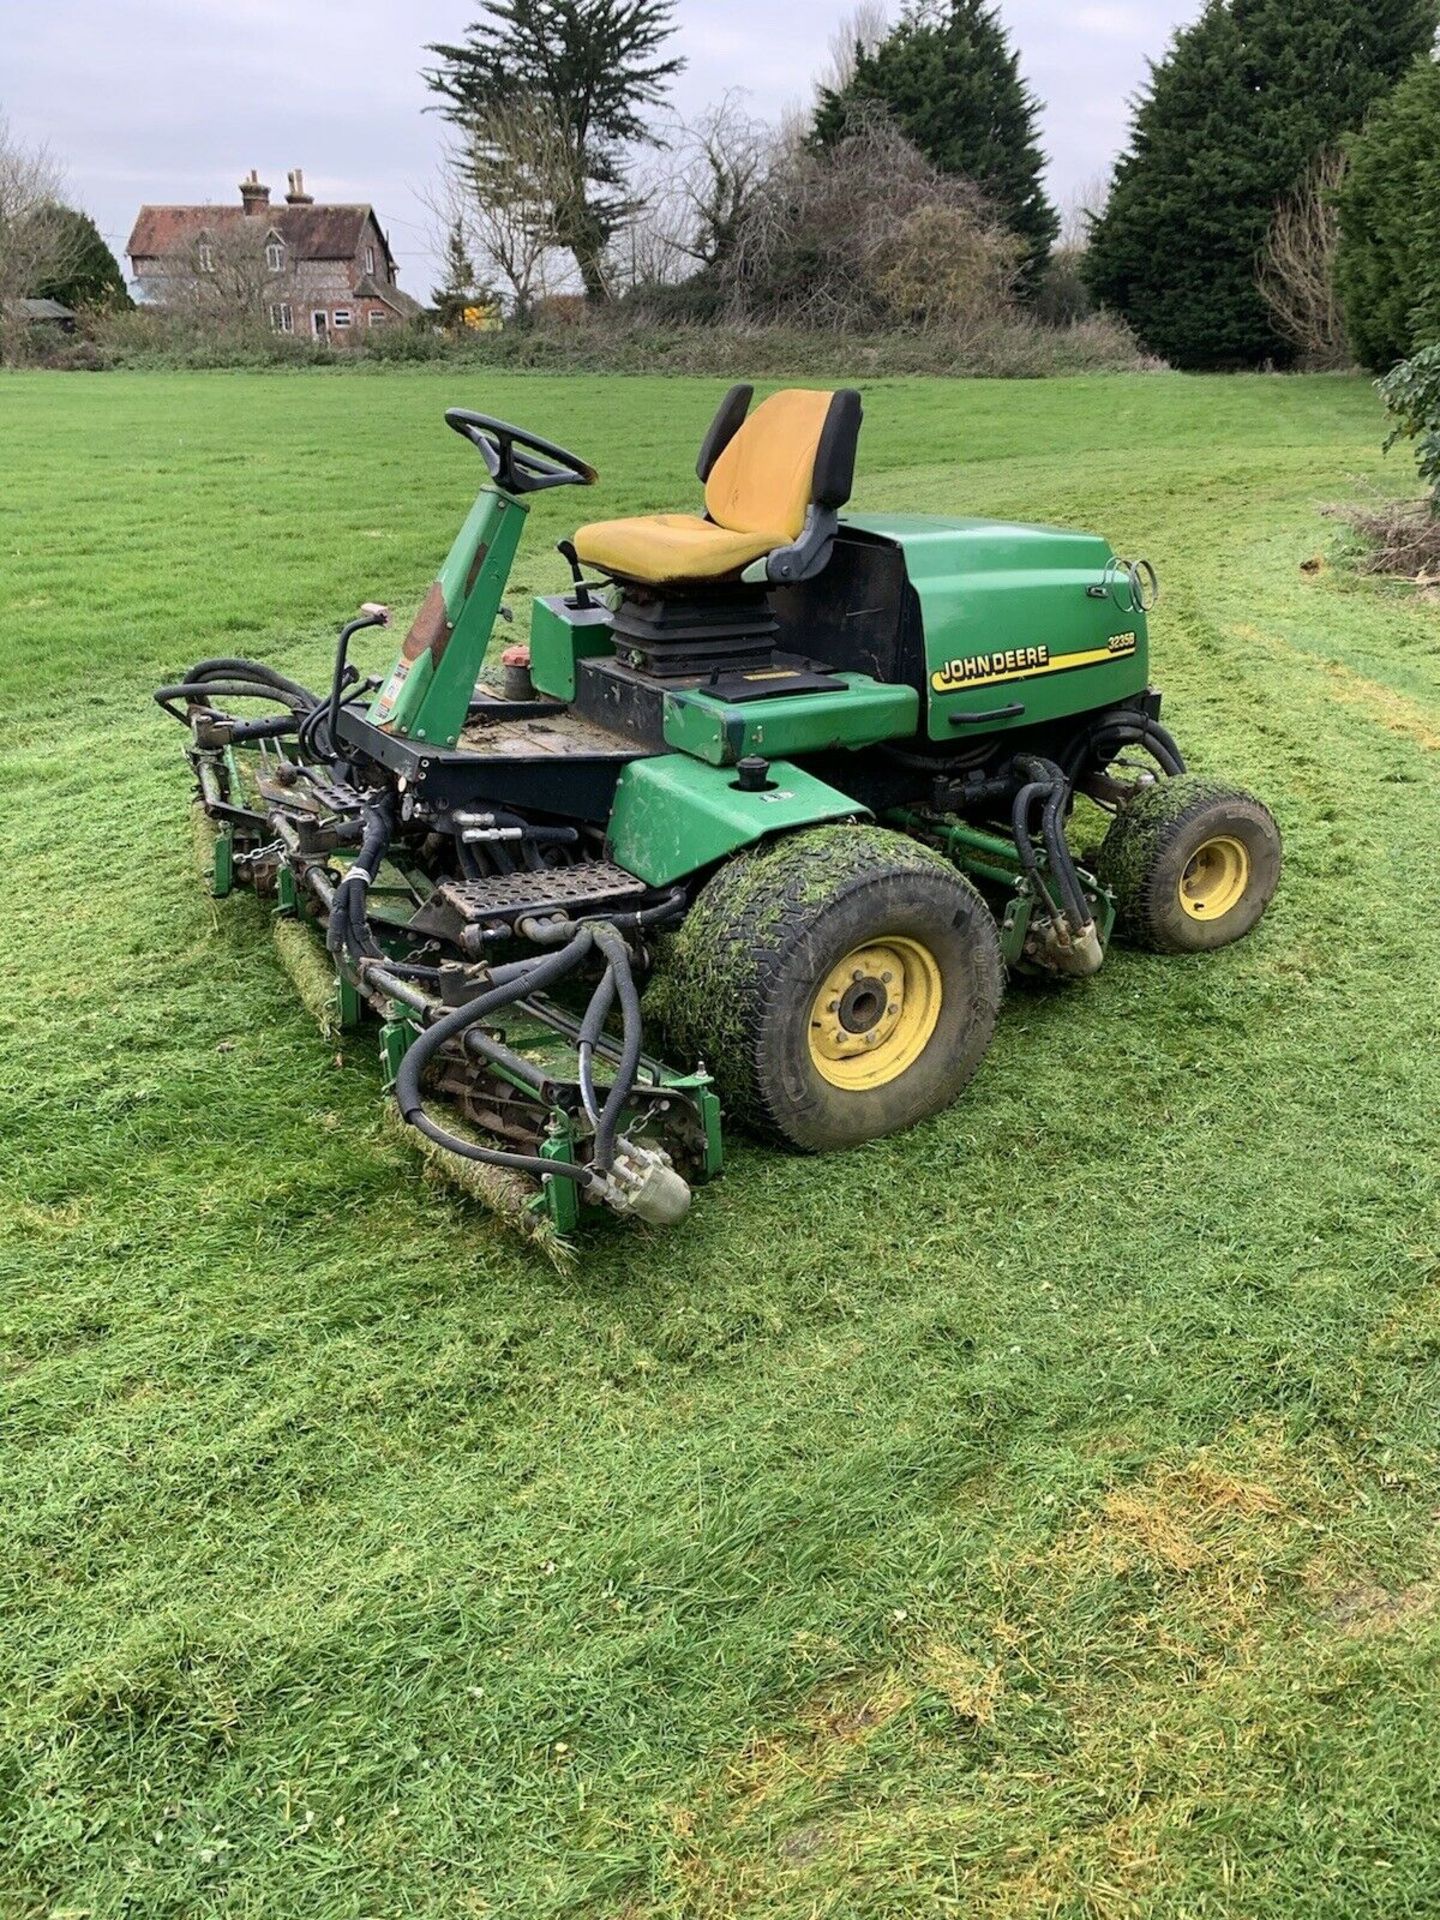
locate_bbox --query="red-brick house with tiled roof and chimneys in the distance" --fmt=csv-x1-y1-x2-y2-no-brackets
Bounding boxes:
125,167,422,346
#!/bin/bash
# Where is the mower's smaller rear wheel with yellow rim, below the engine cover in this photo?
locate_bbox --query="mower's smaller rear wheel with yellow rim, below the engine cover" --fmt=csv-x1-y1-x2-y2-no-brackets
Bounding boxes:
1096,774,1281,954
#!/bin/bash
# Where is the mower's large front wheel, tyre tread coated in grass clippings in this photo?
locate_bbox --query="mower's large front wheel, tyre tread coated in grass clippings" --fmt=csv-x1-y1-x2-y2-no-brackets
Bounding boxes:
655,826,1004,1152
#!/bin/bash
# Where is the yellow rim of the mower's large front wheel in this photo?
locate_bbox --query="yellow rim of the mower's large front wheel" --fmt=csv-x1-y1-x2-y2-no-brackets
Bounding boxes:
810,935,943,1092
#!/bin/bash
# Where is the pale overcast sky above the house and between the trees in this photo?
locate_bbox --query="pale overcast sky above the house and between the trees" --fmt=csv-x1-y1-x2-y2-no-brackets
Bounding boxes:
0,0,1202,298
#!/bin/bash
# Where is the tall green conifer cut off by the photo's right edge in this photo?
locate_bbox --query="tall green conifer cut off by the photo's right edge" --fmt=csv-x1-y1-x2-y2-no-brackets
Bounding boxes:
1336,58,1440,372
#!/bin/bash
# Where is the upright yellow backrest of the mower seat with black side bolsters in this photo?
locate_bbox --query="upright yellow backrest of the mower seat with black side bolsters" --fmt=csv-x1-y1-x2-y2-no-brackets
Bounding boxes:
705,388,860,543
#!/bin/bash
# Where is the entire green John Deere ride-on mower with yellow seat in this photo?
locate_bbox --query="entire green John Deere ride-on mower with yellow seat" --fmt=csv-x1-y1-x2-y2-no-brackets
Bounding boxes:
156,386,1281,1238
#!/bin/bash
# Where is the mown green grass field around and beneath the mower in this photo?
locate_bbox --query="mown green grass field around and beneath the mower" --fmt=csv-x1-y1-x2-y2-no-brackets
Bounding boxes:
0,374,1440,1920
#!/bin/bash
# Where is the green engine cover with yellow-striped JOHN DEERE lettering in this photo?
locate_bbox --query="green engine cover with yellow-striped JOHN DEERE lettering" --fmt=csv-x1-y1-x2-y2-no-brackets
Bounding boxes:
845,513,1150,739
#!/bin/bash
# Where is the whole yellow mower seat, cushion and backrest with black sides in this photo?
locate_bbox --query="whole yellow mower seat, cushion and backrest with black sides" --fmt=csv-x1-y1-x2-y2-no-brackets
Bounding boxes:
574,386,860,586
